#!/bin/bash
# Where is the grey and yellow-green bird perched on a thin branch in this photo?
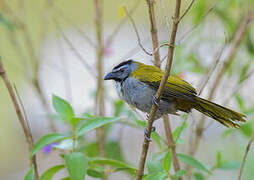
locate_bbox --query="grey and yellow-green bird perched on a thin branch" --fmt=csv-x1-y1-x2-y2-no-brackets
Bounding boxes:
104,60,245,128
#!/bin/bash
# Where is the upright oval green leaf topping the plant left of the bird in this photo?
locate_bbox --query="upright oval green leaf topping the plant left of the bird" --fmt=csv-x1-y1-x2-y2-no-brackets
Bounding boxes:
52,95,75,122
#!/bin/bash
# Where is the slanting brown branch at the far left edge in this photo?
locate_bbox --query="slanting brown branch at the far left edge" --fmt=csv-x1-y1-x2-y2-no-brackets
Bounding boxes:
0,59,39,180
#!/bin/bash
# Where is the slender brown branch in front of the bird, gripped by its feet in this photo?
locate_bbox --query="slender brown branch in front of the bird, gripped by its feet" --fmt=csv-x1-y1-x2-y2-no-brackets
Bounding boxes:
137,0,181,180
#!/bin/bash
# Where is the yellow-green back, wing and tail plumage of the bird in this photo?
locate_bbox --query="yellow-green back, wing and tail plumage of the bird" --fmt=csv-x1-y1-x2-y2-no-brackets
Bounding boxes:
130,62,245,127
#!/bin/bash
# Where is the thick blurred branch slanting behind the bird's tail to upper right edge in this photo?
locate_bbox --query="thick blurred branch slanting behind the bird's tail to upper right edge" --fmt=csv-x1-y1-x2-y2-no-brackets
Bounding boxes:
190,9,254,156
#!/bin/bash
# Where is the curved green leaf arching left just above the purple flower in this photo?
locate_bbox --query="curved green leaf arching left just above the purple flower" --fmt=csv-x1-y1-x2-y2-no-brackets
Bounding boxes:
29,133,69,158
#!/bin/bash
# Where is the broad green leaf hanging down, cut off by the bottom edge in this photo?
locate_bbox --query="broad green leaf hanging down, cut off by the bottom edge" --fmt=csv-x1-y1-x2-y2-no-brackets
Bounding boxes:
65,152,88,180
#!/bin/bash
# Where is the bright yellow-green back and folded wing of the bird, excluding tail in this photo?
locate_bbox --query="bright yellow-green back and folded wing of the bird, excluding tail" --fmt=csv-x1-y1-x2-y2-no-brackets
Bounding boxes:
130,63,197,100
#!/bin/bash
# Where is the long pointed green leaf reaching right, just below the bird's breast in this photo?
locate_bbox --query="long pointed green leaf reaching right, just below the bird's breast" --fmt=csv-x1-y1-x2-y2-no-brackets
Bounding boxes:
76,117,121,137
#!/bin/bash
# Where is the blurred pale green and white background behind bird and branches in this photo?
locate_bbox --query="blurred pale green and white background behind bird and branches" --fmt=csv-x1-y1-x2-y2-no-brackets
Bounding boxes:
0,0,254,180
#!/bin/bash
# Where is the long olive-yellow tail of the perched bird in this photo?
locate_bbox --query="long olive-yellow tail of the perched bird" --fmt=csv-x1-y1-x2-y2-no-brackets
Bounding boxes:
194,97,246,128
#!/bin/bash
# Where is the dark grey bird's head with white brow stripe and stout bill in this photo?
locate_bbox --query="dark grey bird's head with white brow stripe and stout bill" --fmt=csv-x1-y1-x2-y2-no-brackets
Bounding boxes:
104,60,138,82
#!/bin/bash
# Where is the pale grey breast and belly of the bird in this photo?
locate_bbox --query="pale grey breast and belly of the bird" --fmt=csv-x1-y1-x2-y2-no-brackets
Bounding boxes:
116,77,176,119
